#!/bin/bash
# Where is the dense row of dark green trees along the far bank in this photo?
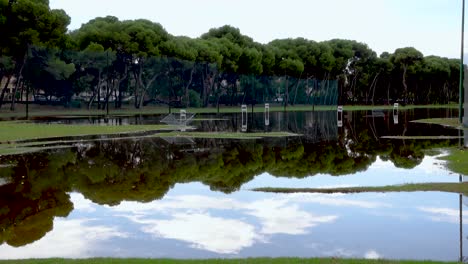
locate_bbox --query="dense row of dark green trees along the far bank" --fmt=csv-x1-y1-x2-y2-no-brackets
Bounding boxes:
0,0,459,109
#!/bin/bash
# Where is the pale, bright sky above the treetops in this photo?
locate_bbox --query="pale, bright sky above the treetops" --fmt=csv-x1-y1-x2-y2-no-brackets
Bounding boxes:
50,0,462,58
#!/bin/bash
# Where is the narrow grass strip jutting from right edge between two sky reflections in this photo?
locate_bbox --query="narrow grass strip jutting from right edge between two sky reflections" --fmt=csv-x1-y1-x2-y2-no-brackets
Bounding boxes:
253,183,468,194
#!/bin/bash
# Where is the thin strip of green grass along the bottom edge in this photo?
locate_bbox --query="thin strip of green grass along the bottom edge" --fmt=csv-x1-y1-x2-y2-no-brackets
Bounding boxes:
0,258,458,264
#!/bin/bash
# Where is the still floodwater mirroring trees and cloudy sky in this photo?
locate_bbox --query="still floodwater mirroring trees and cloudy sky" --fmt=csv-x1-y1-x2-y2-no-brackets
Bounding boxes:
0,110,468,260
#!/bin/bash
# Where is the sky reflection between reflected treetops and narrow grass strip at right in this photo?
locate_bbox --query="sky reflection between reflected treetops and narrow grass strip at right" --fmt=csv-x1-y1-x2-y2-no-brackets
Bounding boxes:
242,156,459,189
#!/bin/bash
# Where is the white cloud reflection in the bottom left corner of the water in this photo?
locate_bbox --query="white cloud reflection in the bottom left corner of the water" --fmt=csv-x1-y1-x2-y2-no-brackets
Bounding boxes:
0,218,128,259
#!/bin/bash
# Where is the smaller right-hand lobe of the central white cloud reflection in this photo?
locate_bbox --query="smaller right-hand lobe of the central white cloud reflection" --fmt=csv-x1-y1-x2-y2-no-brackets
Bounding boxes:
247,199,338,235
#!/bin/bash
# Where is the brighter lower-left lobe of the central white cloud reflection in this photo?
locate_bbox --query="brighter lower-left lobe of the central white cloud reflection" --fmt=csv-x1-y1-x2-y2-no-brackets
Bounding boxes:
142,214,258,254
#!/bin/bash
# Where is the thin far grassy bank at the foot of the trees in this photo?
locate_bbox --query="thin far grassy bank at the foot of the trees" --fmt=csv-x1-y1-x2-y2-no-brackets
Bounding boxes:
0,104,457,118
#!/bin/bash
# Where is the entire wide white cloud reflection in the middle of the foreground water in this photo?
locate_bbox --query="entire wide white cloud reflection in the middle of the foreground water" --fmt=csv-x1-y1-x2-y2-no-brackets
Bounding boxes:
109,195,338,254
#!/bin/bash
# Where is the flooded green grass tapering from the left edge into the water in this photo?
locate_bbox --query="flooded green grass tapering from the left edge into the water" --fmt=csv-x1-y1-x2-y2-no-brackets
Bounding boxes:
0,121,298,155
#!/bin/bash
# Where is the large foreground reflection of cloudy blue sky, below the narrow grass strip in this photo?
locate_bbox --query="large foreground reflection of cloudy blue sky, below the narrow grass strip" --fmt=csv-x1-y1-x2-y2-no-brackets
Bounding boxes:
0,183,468,260
